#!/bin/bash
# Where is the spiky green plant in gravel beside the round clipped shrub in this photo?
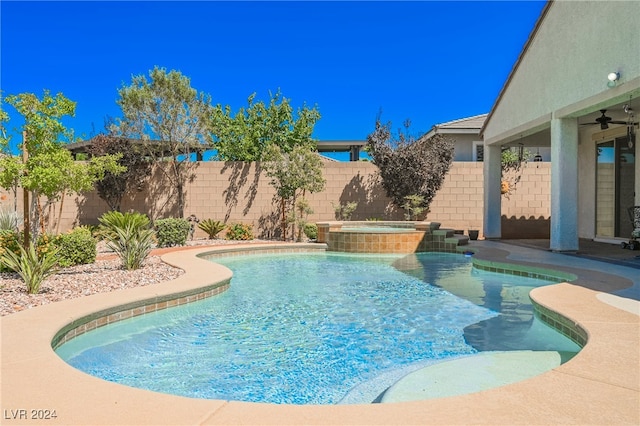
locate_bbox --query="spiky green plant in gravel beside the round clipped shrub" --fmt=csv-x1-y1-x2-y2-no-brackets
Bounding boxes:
105,223,155,270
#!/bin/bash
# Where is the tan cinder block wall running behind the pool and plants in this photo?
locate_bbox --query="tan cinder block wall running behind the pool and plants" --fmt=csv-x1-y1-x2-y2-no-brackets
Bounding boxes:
0,161,550,238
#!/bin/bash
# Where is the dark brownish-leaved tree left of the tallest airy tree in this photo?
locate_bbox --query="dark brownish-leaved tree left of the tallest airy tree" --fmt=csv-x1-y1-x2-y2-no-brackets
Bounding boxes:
89,135,151,211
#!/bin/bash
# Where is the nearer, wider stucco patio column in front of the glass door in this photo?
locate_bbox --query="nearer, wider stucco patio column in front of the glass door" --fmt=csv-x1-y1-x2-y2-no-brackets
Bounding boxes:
550,118,579,251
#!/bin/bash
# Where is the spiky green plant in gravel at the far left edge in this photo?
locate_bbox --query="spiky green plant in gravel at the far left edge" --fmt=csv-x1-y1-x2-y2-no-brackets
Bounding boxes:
0,243,58,294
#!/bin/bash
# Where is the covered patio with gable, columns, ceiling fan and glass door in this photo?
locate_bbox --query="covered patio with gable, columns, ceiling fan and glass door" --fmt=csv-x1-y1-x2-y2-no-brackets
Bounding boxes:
482,1,640,251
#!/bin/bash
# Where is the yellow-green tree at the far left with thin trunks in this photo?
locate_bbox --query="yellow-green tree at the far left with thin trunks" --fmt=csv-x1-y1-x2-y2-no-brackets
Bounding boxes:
0,90,124,241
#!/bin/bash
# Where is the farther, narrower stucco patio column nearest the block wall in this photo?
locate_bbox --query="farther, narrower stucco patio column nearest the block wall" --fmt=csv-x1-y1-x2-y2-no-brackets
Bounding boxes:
482,144,502,239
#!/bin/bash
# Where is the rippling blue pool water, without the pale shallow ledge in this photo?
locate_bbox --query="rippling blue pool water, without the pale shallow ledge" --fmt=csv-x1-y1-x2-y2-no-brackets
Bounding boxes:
57,253,579,404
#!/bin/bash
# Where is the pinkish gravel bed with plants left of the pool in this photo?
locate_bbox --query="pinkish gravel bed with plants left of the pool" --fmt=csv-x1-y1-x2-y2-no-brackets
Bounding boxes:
0,240,272,316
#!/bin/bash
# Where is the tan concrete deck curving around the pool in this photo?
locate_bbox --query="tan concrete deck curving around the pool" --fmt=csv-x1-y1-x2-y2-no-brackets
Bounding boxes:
0,241,640,425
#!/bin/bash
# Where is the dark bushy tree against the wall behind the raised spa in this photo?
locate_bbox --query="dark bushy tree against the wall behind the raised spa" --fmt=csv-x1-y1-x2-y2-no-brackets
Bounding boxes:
367,120,453,220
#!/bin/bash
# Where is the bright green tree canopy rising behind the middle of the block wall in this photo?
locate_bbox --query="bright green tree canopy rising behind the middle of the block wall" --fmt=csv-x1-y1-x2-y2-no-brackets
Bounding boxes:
209,90,320,161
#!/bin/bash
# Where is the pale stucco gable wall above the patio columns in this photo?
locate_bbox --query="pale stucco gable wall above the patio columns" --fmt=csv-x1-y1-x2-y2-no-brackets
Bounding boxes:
484,1,640,144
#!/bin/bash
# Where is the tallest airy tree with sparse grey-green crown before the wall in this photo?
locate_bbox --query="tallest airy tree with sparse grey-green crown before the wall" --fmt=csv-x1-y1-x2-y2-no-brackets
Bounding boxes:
113,67,212,217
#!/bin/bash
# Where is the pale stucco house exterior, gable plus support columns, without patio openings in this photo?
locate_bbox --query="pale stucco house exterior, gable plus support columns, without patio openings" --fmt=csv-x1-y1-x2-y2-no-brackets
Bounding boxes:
482,1,640,251
